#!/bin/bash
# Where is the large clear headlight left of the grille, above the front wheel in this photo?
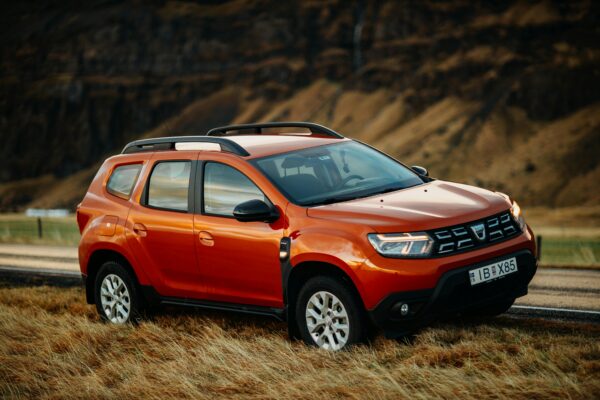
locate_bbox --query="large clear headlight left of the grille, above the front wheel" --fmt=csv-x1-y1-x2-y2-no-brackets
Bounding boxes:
368,232,433,257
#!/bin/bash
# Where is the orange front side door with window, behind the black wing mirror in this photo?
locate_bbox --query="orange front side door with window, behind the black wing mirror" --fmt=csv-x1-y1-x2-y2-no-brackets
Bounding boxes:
194,160,283,307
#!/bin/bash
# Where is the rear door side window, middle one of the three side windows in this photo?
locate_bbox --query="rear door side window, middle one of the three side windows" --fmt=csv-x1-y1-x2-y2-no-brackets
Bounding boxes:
148,161,192,211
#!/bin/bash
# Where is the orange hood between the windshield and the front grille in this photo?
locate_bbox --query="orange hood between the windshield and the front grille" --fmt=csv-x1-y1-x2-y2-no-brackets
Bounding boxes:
307,180,510,233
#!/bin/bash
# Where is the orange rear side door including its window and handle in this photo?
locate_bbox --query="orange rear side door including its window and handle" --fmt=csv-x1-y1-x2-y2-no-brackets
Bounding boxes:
127,151,206,298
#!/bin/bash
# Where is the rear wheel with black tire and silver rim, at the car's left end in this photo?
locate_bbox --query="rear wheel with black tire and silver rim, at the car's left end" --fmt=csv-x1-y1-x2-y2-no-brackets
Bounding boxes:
94,261,144,324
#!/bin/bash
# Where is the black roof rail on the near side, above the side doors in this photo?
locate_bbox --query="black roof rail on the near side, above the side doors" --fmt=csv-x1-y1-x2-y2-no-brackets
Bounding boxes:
121,136,250,157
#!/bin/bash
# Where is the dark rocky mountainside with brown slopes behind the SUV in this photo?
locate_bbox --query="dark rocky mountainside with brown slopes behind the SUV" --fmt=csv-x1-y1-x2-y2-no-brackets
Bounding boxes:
0,0,600,209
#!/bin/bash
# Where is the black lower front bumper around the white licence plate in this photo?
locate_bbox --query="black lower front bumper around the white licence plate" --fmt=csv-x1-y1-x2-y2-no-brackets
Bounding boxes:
369,250,537,337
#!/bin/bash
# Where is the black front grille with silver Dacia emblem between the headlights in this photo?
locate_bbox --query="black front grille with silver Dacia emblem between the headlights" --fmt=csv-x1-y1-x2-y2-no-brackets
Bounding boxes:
428,211,521,256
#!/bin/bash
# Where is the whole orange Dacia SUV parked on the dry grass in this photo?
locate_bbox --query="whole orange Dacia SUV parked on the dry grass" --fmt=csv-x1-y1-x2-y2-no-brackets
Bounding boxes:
77,122,537,350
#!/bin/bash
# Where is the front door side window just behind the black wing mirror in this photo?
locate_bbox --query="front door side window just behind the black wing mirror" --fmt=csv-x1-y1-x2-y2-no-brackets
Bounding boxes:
204,163,267,216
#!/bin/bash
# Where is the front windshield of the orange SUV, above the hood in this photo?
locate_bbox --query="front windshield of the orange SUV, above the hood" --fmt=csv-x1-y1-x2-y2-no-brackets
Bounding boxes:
252,142,423,206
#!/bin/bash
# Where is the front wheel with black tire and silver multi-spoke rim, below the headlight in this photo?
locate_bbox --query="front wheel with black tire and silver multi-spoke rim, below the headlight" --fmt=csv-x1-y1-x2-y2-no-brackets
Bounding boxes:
296,276,367,351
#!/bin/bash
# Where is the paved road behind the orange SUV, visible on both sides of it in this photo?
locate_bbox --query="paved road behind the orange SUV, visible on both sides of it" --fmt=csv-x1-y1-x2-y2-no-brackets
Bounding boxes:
0,244,600,323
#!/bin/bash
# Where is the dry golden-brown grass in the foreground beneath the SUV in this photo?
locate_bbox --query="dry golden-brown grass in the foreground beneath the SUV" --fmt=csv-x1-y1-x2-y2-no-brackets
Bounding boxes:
0,287,600,399
